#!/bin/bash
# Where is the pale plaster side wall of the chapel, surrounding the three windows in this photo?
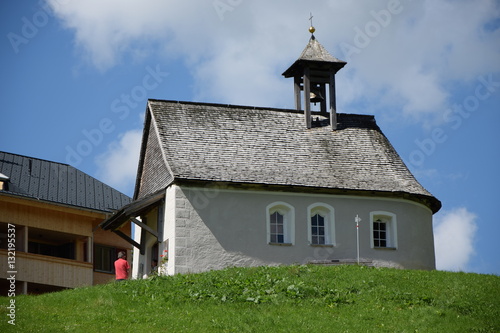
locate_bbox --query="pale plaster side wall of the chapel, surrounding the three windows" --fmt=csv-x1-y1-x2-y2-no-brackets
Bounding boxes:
170,186,435,274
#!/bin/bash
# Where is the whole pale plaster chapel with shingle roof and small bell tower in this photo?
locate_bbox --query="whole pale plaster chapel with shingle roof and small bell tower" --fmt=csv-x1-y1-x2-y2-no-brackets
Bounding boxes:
101,27,441,278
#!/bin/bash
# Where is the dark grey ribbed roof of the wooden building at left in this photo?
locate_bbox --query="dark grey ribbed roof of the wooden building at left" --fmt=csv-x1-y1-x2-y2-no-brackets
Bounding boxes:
0,152,131,212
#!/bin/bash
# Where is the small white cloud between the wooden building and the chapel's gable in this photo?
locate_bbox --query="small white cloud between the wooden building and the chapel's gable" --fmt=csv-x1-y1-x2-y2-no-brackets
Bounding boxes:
96,130,142,195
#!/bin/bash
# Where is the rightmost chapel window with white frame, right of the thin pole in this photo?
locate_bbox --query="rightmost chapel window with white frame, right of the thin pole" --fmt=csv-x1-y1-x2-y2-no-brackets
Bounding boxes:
370,211,398,249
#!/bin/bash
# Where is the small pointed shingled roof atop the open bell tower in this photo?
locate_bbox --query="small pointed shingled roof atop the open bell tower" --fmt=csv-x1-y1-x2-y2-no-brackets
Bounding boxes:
282,35,347,77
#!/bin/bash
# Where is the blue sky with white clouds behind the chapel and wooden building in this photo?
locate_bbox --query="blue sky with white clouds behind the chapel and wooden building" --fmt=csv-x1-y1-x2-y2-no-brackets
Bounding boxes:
0,0,500,274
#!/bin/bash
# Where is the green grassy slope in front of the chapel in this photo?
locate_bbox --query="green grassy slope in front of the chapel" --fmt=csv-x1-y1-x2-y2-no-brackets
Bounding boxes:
0,266,500,333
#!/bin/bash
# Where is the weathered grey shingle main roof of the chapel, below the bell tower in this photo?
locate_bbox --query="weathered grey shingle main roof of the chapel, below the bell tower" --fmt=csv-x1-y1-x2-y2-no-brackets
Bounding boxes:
136,100,441,211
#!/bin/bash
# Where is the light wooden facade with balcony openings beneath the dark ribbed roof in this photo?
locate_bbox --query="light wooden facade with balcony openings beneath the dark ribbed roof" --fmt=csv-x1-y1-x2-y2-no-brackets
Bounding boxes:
0,189,131,295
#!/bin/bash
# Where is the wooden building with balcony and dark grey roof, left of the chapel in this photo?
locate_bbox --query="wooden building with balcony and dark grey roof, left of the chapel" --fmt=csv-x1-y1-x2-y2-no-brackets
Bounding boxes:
0,152,131,296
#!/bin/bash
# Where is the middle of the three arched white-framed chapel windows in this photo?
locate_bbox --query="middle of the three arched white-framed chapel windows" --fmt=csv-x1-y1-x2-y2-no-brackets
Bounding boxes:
307,203,335,246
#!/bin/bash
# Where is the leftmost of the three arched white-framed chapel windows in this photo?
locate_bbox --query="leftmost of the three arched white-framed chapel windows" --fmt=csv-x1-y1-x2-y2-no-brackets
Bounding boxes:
266,202,295,245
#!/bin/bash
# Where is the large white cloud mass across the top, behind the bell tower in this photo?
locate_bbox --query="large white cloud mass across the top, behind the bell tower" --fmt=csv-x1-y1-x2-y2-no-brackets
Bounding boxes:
48,0,500,119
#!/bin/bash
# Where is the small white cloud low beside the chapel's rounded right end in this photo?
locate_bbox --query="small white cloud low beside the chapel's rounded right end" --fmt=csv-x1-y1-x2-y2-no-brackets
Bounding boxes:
434,207,478,271
